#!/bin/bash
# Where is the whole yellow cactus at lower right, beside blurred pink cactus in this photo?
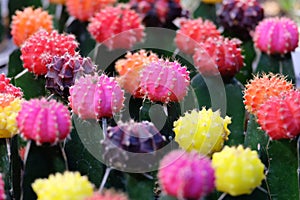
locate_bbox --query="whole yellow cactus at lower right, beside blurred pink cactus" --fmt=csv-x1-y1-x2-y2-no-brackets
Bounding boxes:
212,145,265,196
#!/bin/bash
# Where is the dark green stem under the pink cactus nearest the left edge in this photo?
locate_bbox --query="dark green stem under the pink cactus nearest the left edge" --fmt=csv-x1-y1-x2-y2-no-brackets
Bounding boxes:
22,141,67,199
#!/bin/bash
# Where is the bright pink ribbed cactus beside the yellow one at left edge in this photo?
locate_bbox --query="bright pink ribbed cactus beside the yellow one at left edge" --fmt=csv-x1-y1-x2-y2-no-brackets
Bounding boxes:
17,98,72,145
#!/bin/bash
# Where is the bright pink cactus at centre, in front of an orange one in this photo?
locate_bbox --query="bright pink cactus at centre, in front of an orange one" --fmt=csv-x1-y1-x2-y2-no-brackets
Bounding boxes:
140,59,190,103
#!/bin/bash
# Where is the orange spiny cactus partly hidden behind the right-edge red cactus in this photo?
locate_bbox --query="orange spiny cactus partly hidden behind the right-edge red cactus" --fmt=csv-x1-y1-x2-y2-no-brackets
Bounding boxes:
244,73,293,114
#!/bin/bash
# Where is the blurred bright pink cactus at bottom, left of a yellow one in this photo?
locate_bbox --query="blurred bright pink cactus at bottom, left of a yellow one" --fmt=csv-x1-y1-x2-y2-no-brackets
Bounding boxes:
158,150,215,199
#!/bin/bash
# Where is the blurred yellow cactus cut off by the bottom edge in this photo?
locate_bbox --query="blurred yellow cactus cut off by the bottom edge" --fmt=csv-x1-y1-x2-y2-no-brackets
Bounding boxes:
32,171,93,200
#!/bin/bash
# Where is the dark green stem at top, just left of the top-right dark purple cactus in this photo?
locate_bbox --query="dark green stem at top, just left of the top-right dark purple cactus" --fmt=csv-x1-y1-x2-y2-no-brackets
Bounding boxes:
193,2,217,23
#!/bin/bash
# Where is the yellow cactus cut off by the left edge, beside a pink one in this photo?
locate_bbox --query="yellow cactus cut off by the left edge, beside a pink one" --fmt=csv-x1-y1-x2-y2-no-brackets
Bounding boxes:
0,94,22,138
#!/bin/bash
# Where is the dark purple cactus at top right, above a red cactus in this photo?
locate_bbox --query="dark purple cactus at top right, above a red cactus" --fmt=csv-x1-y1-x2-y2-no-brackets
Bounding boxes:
217,0,264,40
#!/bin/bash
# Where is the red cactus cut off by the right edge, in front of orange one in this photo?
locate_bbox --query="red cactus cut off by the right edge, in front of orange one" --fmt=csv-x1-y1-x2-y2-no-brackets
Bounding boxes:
257,90,300,140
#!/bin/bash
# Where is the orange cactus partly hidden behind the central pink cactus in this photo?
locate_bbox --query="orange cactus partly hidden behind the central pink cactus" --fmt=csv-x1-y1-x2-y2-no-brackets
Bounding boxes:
115,50,159,97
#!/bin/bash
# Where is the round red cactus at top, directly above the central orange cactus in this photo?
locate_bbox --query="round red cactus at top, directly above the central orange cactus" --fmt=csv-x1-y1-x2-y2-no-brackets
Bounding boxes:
88,5,144,50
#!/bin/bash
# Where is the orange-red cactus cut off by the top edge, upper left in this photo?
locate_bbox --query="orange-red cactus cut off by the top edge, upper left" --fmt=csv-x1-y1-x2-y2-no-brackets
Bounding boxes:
65,0,116,21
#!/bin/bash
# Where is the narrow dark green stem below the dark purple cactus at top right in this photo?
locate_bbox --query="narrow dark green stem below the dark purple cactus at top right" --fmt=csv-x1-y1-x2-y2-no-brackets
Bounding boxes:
235,40,256,84
